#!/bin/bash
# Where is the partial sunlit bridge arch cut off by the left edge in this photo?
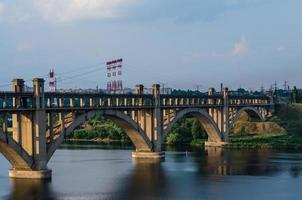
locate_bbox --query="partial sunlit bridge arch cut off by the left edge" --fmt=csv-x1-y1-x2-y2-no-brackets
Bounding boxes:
0,130,33,170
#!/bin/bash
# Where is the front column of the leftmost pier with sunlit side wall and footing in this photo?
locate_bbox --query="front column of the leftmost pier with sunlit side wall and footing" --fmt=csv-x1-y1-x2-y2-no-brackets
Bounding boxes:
9,79,51,179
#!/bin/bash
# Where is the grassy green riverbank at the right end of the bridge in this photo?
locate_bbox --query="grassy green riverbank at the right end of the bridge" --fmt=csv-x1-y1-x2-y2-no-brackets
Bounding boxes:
225,104,302,149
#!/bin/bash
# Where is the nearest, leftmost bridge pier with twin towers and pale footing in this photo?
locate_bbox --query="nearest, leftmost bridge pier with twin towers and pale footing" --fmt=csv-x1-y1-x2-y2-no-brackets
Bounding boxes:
7,78,51,179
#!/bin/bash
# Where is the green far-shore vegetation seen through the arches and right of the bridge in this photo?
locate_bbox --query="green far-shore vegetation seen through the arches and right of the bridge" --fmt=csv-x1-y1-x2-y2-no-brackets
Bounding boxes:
65,104,302,149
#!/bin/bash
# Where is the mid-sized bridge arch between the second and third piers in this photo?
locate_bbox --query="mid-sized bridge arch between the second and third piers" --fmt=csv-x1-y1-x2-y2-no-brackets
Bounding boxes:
163,108,223,142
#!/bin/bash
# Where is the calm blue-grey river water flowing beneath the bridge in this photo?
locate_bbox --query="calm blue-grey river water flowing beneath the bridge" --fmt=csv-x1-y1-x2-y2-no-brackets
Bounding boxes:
0,142,302,200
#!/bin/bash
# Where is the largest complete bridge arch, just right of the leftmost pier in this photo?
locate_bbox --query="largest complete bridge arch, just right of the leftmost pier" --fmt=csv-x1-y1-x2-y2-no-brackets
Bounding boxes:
47,110,152,160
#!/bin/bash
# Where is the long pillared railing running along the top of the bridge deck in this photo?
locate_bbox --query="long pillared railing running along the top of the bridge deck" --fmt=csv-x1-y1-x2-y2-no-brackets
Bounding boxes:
0,92,273,110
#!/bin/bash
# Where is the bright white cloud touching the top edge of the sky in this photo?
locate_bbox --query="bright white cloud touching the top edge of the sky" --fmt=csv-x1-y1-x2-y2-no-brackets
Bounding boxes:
33,0,137,22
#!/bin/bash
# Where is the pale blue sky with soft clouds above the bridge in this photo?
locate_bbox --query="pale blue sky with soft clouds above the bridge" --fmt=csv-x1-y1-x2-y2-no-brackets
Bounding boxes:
0,0,302,90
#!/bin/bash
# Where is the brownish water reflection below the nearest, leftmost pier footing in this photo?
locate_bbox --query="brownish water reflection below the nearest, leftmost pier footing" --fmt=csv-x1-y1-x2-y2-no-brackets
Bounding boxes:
7,179,56,200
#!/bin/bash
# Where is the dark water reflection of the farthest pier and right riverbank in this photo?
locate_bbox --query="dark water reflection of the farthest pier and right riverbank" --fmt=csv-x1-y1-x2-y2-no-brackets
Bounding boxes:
195,147,281,176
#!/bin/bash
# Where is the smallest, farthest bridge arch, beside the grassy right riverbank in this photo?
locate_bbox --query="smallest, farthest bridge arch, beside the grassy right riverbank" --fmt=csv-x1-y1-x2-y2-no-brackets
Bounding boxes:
229,107,265,132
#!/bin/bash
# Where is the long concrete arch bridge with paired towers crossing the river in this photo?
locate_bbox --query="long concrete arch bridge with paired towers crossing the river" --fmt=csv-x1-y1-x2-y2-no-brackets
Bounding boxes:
0,78,274,179
